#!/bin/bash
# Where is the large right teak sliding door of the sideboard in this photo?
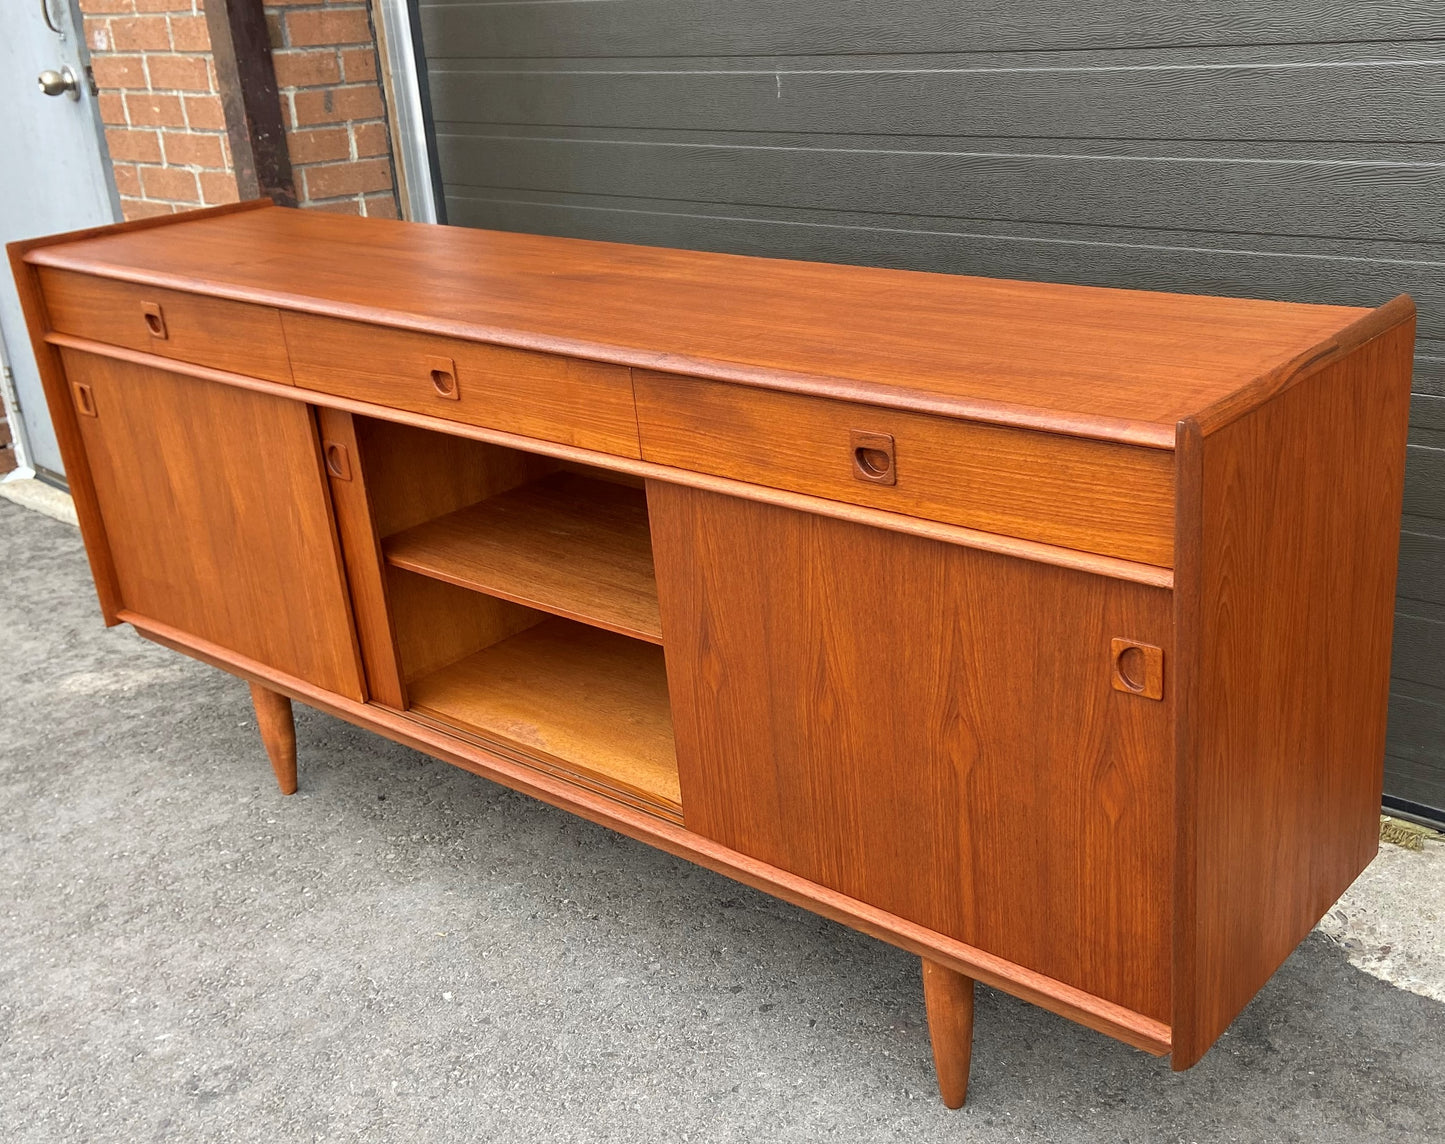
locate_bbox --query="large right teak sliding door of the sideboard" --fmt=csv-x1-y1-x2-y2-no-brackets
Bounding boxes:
647,482,1173,1021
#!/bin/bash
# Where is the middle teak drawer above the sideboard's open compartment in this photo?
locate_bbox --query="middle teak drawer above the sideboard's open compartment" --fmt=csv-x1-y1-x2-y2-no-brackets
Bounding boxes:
282,312,642,456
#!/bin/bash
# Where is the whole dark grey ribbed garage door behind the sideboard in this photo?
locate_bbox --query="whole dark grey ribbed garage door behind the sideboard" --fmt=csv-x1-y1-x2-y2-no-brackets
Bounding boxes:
419,0,1445,809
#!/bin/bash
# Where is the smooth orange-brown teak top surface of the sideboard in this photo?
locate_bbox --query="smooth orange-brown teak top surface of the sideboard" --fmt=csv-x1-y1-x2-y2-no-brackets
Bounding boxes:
26,208,1383,448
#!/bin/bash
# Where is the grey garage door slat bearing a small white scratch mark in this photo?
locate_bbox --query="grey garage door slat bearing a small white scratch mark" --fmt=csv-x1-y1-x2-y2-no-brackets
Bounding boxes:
431,59,1445,143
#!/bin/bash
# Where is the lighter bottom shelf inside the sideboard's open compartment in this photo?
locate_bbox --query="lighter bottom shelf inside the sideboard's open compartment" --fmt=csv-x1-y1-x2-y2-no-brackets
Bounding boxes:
409,620,682,822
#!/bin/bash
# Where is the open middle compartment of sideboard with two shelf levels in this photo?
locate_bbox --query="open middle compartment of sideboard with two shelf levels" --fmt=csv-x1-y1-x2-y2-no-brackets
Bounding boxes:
354,417,682,823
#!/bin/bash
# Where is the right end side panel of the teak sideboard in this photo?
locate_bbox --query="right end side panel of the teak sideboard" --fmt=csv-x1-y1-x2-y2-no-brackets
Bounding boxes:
1173,319,1413,1069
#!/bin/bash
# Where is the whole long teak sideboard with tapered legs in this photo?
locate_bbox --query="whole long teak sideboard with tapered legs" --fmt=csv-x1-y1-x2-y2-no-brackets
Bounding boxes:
10,204,1415,1106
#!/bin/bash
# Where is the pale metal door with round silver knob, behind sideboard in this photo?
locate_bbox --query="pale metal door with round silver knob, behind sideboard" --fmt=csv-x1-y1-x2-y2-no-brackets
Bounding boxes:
0,0,120,477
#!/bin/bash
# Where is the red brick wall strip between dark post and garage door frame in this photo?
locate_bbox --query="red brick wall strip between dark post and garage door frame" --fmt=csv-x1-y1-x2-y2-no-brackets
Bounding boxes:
266,0,396,218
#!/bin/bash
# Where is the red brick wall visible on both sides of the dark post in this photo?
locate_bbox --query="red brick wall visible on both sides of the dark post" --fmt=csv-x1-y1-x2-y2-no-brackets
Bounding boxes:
79,0,397,218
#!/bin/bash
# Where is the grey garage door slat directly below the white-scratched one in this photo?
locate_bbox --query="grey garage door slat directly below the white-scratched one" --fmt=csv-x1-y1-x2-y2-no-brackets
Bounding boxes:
441,136,1445,243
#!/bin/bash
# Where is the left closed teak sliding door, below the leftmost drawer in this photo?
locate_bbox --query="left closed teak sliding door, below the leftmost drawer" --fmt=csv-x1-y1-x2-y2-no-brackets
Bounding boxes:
64,350,364,699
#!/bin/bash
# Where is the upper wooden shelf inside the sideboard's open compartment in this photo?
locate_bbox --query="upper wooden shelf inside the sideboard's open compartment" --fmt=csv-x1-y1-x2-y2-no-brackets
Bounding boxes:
384,472,662,644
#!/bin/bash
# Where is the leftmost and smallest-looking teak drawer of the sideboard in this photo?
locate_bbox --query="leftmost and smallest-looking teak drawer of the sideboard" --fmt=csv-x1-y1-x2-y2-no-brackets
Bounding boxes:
40,267,290,386
